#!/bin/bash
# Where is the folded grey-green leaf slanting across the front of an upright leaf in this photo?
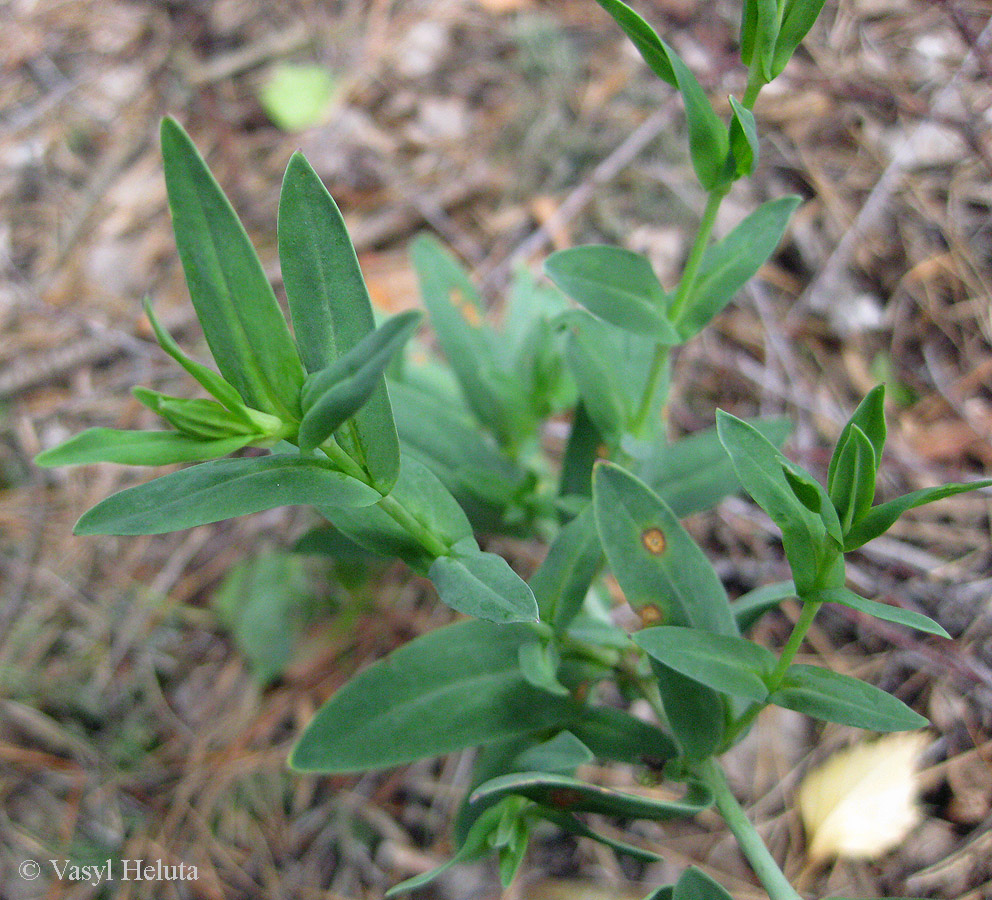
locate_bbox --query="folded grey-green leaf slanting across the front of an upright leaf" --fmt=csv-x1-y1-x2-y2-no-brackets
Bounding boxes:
299,310,423,450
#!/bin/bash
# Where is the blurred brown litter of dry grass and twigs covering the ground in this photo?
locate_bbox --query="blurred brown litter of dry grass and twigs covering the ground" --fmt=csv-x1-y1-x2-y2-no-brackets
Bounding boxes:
0,0,992,900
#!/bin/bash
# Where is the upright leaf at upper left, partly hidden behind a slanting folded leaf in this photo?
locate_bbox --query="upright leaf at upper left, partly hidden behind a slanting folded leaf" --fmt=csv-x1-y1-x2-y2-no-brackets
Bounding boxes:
279,153,400,493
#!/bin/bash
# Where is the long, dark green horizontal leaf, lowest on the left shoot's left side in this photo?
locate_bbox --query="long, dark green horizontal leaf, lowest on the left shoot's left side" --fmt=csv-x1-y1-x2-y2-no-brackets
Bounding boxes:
75,453,381,534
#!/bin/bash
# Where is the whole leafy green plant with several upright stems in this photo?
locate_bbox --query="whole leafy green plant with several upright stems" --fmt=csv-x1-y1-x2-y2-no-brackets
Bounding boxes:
38,0,992,900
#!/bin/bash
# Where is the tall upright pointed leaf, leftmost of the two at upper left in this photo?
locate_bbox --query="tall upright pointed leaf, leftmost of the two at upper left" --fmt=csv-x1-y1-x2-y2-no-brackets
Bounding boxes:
162,118,304,419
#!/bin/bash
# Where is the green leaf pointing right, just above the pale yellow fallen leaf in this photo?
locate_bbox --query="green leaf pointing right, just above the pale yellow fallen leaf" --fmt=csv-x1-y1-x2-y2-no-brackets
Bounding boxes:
768,666,929,731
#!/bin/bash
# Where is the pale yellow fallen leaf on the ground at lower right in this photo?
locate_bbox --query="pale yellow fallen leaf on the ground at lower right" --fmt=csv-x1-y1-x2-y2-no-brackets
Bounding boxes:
797,732,929,861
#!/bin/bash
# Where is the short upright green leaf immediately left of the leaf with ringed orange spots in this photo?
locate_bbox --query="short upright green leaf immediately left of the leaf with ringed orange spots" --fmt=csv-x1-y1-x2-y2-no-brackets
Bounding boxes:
530,504,603,630
